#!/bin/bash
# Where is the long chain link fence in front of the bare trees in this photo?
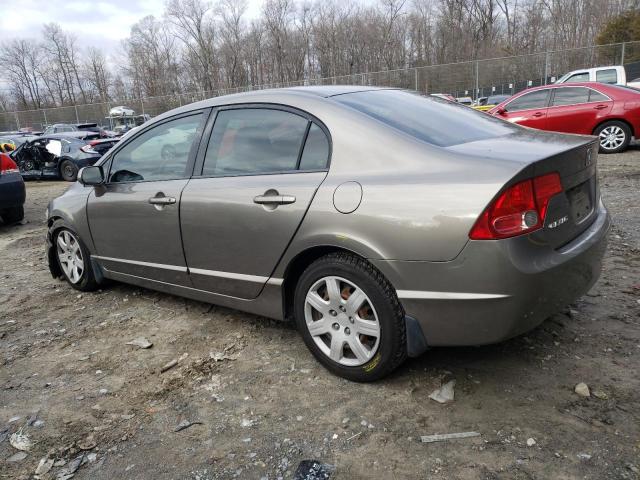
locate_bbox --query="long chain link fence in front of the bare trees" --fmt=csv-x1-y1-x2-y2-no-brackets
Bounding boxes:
0,41,640,131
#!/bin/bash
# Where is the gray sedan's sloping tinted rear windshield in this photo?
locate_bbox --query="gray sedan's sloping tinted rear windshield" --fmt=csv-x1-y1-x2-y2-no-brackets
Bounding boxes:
333,90,517,147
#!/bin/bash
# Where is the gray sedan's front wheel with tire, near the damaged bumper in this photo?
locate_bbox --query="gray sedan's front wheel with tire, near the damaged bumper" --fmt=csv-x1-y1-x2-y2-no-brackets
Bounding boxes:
53,228,98,292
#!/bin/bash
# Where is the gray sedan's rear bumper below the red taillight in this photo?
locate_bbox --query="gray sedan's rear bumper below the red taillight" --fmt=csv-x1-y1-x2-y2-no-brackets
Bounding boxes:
373,203,610,346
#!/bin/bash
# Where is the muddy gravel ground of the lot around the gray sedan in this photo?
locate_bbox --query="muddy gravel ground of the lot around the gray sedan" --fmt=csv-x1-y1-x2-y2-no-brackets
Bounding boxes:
0,151,640,479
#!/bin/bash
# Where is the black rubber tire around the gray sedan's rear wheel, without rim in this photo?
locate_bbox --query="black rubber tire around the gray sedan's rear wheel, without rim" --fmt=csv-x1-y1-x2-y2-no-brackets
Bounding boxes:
294,252,407,382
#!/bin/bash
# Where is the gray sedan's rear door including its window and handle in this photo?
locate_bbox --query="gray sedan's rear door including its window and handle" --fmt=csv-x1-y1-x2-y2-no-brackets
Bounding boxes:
180,106,330,299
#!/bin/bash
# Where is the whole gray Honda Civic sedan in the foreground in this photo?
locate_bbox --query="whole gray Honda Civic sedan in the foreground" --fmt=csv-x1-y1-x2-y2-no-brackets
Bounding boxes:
47,86,610,381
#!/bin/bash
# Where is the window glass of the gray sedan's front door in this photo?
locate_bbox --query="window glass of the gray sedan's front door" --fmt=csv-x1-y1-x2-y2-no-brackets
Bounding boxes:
109,113,203,183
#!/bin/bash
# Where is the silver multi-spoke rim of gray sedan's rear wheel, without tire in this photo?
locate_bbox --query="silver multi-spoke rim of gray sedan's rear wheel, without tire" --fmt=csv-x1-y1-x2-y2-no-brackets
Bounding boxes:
304,276,381,367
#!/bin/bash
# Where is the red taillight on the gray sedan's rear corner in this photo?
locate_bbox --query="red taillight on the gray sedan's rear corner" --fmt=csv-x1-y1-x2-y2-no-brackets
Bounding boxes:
469,173,562,240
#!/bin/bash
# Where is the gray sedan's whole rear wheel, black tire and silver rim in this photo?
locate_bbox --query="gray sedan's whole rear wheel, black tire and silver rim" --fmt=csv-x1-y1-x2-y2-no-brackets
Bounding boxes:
294,253,407,382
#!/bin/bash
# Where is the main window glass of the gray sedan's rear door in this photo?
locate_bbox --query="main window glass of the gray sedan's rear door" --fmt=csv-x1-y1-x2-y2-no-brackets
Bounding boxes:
202,108,309,176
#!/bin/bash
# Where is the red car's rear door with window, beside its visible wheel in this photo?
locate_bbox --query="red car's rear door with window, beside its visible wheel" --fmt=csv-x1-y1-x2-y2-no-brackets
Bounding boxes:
547,87,613,135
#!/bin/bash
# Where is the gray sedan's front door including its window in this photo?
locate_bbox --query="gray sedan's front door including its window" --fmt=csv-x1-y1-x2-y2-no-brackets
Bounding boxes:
87,111,206,285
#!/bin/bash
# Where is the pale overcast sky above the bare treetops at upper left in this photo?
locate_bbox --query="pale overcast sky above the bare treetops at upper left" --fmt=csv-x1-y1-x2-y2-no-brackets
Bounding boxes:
0,0,262,53
